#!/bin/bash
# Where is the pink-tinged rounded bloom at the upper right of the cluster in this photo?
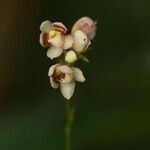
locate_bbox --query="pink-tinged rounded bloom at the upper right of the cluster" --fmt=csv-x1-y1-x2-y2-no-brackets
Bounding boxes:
72,17,97,39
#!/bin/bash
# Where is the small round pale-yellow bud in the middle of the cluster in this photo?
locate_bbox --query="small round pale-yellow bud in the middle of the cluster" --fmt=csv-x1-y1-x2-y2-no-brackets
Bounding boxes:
65,50,77,63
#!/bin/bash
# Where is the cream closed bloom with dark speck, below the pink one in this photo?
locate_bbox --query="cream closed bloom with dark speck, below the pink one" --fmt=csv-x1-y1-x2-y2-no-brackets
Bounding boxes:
73,30,88,53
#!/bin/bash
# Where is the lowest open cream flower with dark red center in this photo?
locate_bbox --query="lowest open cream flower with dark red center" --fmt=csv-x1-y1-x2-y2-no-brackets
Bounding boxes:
48,64,85,100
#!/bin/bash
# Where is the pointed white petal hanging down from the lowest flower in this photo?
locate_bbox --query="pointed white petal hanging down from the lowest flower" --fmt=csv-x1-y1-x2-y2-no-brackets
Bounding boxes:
60,81,75,100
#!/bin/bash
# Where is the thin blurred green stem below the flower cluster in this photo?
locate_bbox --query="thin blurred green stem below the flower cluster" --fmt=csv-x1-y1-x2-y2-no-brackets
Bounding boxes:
65,101,74,150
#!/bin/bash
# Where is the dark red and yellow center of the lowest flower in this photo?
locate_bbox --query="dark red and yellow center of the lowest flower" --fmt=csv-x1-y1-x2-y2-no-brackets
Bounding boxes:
52,68,65,83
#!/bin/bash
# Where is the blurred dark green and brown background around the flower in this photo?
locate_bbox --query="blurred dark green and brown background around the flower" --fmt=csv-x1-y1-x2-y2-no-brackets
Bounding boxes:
0,0,150,150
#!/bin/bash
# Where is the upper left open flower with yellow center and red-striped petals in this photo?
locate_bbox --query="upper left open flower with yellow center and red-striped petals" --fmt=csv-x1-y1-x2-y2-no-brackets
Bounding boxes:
40,20,67,59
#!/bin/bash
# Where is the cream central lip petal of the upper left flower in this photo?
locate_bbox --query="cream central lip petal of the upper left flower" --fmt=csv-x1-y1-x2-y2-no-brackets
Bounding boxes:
48,33,64,47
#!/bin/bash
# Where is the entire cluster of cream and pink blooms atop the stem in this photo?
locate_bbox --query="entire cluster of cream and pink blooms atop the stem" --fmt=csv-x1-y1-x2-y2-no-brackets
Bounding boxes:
40,17,96,99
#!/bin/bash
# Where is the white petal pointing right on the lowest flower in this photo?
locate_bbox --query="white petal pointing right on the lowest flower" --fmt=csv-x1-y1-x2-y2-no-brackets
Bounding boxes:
72,67,85,82
